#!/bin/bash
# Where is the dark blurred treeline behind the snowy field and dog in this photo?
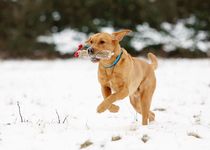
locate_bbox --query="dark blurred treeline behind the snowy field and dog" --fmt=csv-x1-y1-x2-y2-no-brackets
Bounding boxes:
0,0,210,58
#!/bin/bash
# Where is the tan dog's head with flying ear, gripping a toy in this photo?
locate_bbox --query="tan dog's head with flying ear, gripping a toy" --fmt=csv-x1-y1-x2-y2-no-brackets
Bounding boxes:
86,30,131,62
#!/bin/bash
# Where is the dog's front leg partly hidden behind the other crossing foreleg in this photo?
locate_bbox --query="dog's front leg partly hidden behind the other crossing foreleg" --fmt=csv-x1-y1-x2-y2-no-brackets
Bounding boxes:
101,87,120,113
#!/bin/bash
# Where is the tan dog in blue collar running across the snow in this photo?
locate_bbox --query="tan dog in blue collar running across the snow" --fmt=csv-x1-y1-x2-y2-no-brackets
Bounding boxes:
86,30,157,125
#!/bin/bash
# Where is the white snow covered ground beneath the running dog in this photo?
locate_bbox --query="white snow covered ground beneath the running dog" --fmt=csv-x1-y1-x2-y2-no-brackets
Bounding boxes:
0,59,210,150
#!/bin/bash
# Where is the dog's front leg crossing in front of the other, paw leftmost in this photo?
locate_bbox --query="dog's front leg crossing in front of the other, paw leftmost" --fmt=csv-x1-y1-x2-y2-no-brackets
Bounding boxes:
97,87,128,113
